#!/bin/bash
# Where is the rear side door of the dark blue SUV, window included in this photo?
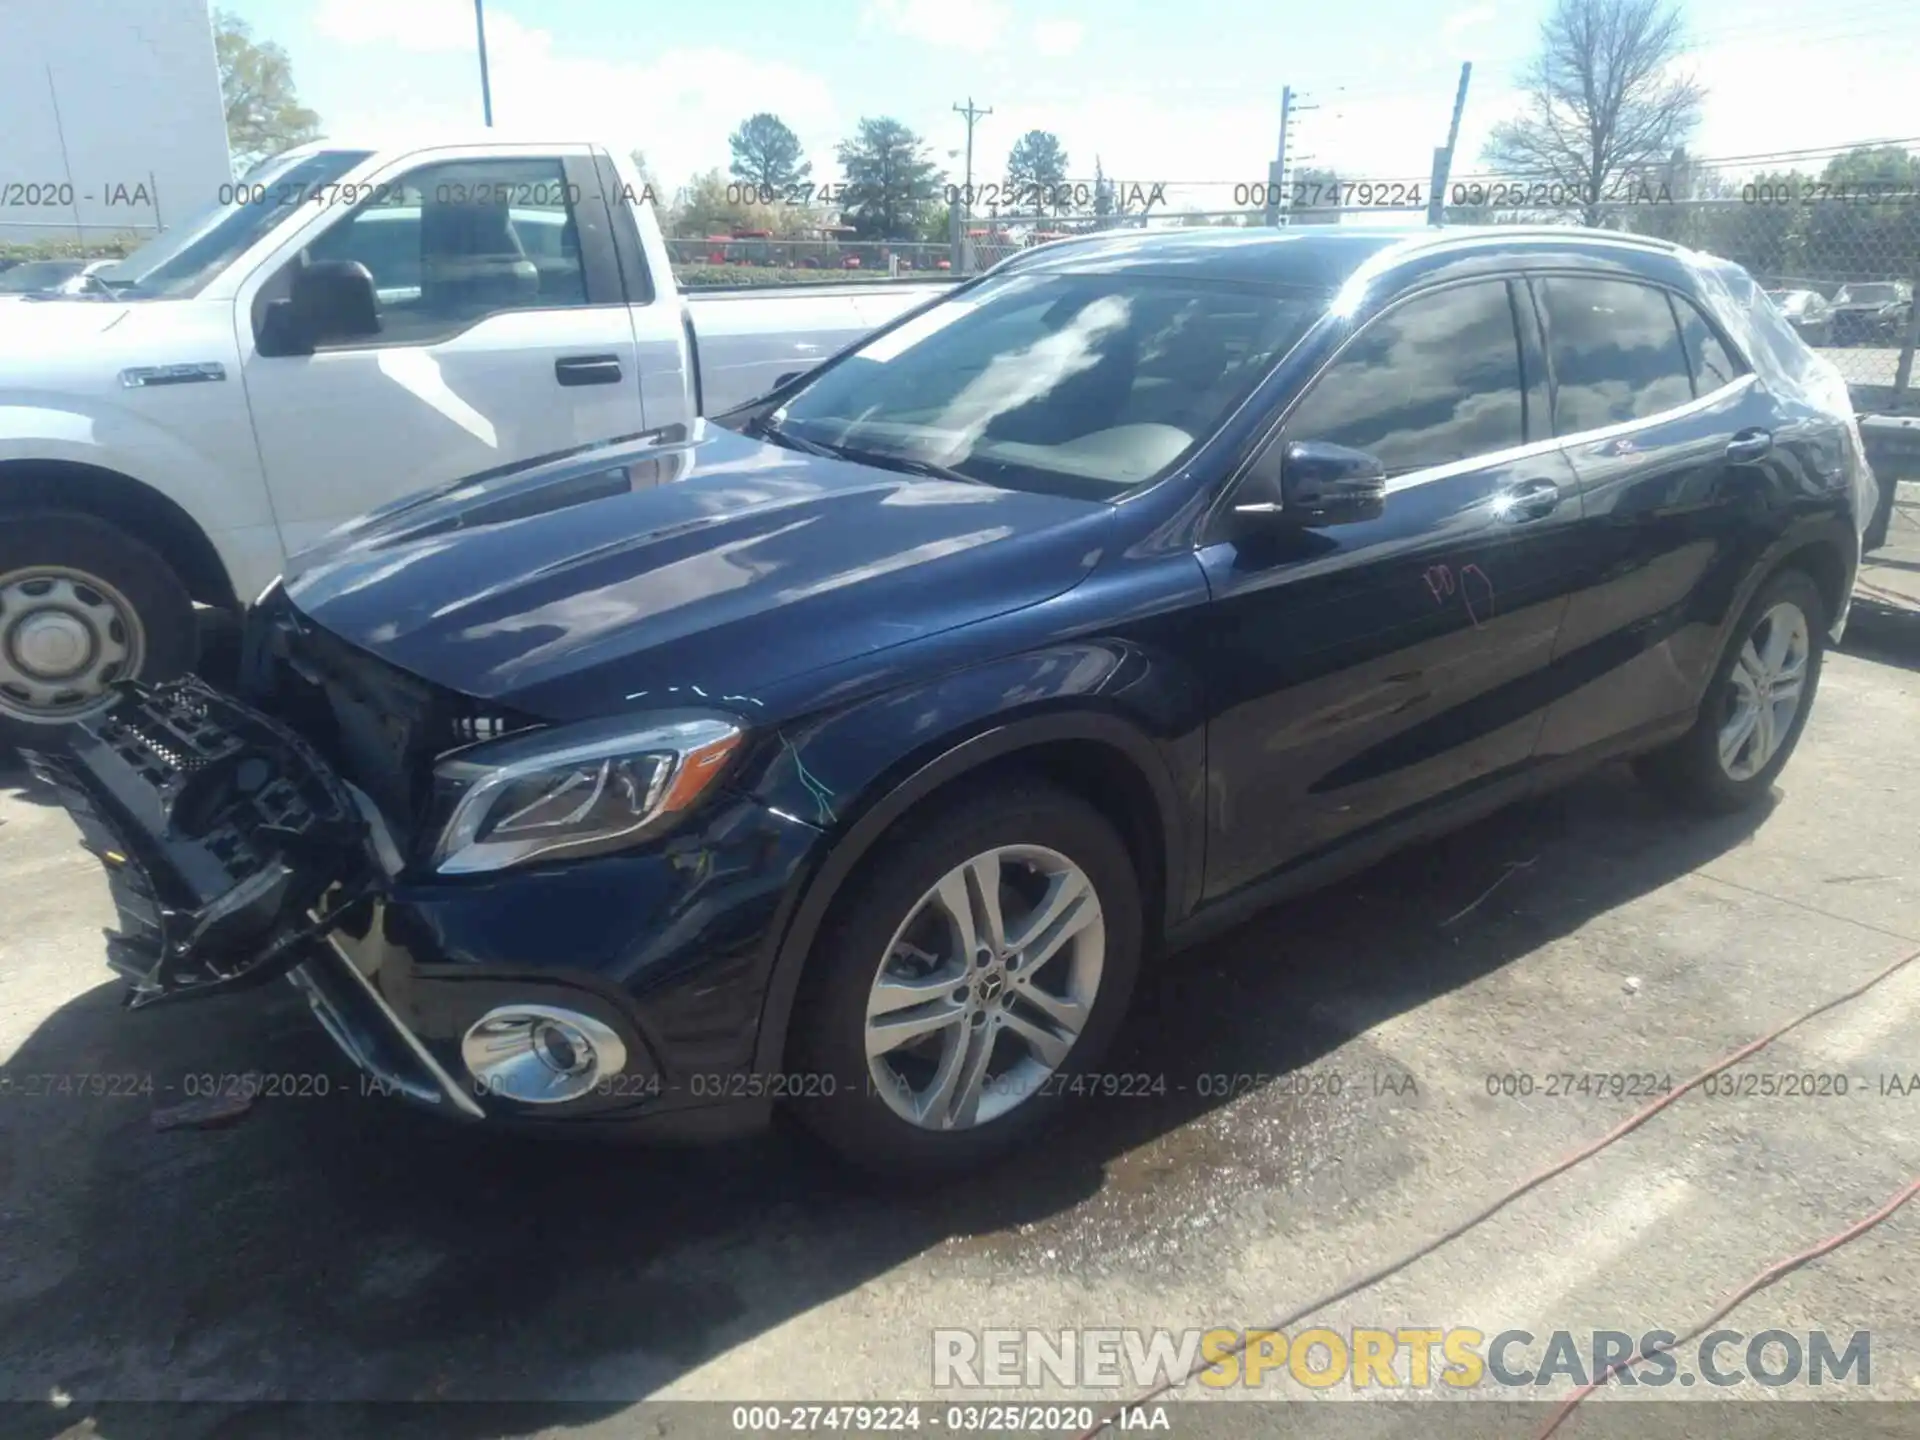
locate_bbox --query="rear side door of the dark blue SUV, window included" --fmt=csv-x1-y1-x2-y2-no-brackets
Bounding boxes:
1530,273,1793,758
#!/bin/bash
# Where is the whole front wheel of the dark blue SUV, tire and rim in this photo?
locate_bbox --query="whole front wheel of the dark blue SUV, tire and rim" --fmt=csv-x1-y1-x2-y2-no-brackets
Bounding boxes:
789,781,1142,1181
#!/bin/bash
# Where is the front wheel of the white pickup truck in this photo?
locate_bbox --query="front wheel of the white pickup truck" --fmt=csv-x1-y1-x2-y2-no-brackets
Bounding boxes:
0,511,196,745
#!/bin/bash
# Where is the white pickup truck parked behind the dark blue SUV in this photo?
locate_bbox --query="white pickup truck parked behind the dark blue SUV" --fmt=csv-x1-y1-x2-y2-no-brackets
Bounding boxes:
0,140,941,739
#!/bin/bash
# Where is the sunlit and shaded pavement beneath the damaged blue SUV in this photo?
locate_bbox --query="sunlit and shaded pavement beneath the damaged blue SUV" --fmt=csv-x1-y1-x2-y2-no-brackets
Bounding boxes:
0,612,1920,1440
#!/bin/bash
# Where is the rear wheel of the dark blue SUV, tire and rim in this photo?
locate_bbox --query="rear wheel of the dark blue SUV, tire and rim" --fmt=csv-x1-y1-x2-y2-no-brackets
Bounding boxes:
1634,570,1826,814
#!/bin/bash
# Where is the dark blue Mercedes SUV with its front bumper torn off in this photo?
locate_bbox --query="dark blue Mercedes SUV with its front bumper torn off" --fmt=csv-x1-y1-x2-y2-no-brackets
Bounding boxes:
35,227,1872,1173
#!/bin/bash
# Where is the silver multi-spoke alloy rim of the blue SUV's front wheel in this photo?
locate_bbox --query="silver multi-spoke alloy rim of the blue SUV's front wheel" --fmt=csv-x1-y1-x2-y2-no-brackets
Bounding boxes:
864,845,1106,1131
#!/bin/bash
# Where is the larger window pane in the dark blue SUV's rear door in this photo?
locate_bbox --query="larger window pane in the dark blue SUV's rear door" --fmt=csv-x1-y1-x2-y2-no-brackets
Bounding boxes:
1534,276,1693,436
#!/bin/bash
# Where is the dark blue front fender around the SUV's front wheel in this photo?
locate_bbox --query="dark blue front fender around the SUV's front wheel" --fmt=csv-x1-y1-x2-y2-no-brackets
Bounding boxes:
755,639,1206,1073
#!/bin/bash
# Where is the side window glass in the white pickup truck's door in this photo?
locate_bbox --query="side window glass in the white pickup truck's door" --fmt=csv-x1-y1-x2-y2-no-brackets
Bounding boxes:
293,157,588,346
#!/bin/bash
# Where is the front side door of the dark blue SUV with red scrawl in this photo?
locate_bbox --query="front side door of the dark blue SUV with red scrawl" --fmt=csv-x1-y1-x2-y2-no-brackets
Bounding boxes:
1200,278,1580,899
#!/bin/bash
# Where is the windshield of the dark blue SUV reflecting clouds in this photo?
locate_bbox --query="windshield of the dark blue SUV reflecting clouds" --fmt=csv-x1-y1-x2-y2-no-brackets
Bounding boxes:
758,275,1327,499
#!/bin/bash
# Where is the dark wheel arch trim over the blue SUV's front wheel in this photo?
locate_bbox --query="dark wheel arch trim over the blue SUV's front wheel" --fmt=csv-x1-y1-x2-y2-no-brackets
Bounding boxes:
755,710,1192,1073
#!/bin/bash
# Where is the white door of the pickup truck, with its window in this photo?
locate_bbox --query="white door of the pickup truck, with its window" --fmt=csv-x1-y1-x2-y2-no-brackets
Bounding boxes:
236,146,645,553
